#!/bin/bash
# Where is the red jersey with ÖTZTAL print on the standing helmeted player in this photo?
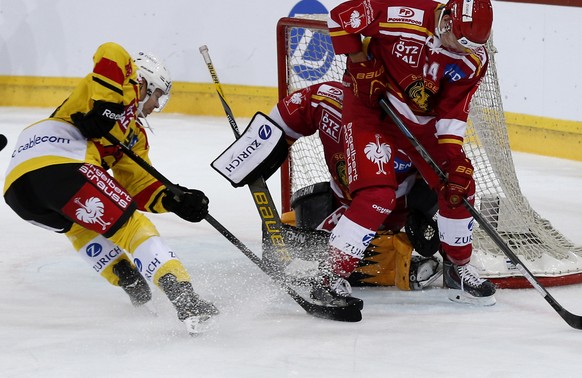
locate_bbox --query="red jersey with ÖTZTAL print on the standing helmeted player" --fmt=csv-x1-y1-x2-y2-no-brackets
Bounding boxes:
328,0,488,151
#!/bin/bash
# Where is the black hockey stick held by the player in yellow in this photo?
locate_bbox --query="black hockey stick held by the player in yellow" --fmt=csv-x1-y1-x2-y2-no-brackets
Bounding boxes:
104,133,362,322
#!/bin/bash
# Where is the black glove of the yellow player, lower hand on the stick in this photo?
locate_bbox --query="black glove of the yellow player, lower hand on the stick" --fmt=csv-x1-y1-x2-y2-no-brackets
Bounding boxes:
162,187,209,222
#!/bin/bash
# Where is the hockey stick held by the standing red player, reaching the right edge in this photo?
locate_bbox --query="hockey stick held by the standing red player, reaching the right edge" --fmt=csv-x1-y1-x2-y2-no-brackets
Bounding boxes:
380,99,582,329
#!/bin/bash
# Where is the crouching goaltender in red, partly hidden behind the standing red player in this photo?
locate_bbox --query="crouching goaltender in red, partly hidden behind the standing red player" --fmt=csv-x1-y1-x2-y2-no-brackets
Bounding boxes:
269,81,440,290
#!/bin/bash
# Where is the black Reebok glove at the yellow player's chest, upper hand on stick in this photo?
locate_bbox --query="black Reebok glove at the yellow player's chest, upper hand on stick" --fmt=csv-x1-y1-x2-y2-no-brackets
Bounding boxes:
71,101,125,139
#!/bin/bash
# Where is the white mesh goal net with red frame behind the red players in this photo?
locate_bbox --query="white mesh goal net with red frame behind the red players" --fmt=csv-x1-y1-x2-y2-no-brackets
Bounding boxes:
277,14,582,288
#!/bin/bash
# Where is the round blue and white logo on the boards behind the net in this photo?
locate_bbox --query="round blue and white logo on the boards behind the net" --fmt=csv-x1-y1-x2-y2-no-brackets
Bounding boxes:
289,0,335,82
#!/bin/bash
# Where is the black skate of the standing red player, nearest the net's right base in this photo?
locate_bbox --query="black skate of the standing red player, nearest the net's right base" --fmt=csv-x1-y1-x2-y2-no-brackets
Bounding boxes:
443,260,495,306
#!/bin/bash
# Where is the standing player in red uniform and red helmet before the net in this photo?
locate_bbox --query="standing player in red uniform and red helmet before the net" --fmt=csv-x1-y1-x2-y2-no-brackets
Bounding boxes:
321,0,495,305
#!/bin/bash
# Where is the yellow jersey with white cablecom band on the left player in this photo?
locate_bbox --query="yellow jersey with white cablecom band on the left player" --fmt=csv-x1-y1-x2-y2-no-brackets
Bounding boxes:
4,42,166,212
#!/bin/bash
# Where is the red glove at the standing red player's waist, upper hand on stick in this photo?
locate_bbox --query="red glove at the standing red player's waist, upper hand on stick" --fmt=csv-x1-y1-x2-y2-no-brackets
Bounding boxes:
343,59,388,107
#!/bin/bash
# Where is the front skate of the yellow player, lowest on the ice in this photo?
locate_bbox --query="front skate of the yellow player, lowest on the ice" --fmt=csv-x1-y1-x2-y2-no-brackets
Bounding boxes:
159,273,219,335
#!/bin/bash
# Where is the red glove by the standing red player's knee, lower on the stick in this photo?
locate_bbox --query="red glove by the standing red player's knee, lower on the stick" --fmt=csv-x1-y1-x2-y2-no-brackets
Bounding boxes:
441,155,473,208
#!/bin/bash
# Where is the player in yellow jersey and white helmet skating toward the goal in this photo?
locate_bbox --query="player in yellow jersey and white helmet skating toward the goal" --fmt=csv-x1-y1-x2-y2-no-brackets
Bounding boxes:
4,42,218,334
